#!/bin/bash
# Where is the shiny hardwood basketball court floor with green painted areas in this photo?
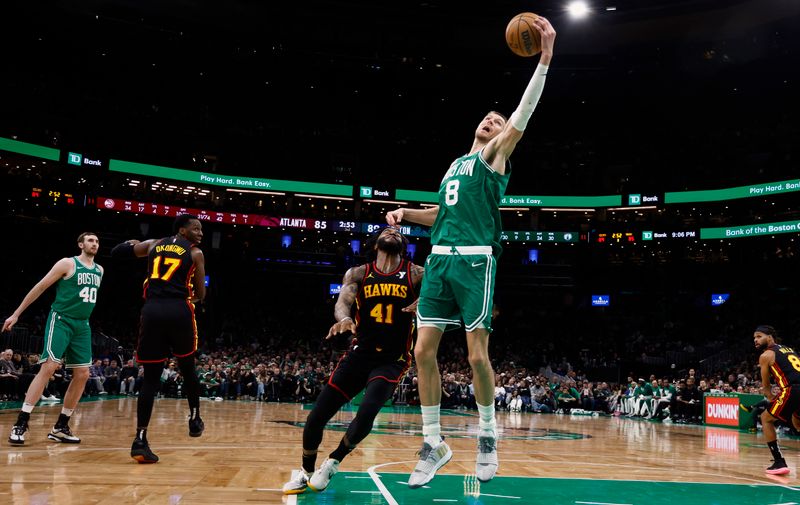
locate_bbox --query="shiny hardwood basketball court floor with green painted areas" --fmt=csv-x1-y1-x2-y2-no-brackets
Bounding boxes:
0,398,800,505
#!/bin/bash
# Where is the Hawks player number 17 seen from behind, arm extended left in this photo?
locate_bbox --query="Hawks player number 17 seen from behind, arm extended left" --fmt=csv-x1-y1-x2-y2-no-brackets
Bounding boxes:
111,214,206,463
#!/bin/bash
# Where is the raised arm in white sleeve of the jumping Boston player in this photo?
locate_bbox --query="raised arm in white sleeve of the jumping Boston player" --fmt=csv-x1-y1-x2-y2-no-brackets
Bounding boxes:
483,16,556,169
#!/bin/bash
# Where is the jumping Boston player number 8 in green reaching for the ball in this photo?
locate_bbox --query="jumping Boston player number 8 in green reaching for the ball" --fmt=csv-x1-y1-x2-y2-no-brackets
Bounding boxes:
386,17,556,488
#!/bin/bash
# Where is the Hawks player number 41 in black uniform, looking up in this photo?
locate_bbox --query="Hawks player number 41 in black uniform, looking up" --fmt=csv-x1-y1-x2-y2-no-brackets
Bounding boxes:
283,228,424,494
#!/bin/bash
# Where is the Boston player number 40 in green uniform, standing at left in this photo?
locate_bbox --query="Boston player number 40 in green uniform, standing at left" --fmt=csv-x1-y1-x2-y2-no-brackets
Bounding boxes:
3,232,103,445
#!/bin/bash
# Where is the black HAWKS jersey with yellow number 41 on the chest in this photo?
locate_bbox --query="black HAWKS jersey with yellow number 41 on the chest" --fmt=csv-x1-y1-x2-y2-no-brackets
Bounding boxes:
356,260,417,363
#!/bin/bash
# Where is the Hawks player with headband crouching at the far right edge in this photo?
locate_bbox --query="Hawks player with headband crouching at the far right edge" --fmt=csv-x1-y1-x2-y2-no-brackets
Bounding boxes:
753,325,800,475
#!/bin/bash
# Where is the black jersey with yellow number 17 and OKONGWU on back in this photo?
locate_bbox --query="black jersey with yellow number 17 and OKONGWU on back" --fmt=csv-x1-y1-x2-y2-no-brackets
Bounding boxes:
144,235,195,300
